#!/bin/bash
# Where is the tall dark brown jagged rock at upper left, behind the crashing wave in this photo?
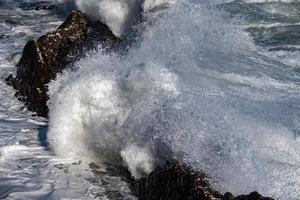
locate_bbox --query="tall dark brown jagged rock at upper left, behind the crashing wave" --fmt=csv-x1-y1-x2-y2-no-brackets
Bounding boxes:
7,11,120,117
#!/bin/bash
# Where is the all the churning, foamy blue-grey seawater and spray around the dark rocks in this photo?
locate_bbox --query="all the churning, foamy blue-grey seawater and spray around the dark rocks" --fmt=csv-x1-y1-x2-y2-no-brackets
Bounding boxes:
0,0,300,200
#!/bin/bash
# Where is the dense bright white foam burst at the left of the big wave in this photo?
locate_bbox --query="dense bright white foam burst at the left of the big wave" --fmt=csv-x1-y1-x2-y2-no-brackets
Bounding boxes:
50,52,178,177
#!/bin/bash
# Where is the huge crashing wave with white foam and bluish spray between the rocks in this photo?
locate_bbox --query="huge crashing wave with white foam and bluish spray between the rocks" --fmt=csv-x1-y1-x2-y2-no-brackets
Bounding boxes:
49,0,300,199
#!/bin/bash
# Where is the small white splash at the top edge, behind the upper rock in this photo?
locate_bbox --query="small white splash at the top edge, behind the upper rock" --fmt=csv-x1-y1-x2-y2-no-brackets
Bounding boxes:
57,0,174,37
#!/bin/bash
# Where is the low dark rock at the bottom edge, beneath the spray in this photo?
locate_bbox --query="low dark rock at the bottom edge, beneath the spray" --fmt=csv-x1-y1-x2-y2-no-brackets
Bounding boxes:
131,162,272,200
